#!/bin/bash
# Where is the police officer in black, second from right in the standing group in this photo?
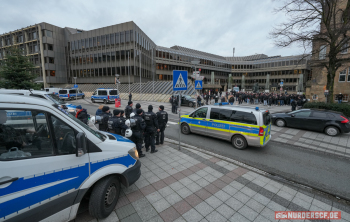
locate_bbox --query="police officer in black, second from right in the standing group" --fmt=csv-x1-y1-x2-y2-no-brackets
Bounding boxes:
144,105,159,153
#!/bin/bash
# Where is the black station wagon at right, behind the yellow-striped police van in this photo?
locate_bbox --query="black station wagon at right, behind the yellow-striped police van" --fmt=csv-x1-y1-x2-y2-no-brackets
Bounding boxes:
272,109,350,136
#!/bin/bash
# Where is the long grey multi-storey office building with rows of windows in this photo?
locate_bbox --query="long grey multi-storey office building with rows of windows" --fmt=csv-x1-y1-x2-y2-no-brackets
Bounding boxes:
0,22,310,92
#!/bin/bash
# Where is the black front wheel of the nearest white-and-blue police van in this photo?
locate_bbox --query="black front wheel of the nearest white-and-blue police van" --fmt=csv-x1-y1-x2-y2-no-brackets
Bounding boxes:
89,176,121,219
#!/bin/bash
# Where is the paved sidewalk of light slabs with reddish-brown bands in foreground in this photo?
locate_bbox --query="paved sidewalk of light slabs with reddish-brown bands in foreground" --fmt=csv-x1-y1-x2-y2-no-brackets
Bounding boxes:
75,139,350,222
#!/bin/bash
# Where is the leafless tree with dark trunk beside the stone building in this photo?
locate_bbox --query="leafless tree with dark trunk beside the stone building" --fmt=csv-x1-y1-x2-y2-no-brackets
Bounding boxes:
270,0,350,102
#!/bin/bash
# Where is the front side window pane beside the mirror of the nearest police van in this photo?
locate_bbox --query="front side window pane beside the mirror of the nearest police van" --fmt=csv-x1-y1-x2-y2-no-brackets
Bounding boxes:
50,116,76,155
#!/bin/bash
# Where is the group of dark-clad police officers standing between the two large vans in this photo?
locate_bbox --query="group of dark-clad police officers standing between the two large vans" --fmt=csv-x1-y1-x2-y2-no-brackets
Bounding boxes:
92,101,168,158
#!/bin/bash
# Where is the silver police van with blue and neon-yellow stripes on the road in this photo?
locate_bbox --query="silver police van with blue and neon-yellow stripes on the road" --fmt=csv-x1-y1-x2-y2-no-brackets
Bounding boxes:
180,103,271,149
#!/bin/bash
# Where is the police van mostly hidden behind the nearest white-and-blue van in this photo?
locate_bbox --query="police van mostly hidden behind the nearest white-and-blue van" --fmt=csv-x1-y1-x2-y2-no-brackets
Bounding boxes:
0,89,76,114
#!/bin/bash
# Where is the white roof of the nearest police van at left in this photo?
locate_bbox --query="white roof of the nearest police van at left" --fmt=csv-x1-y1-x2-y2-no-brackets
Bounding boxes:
0,95,53,106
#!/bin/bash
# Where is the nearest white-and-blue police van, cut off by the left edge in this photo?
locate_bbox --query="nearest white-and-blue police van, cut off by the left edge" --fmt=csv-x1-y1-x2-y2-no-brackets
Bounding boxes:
0,95,141,221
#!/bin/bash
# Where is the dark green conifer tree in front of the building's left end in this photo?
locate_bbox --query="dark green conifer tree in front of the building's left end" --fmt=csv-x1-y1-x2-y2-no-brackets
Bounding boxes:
0,47,38,89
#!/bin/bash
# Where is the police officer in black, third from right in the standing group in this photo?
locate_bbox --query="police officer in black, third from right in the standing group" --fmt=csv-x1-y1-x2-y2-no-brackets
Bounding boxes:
131,109,146,158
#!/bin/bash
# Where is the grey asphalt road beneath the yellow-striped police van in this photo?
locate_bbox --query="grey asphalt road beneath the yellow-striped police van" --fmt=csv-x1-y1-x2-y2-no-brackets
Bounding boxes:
72,102,350,200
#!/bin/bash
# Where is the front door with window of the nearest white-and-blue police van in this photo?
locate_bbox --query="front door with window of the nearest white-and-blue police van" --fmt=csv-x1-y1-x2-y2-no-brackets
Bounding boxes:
0,107,89,221
